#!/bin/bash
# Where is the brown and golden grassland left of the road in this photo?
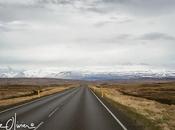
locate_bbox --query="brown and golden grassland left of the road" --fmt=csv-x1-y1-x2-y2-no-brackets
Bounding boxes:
0,85,74,109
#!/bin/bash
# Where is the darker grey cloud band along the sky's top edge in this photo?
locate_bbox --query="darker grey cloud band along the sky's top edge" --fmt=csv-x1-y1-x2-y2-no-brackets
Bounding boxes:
0,0,175,15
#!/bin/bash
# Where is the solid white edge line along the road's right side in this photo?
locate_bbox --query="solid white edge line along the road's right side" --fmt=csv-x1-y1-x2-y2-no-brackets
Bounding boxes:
91,90,127,130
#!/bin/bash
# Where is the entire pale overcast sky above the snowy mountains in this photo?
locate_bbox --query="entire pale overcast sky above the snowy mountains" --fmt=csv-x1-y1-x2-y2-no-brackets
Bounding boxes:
0,0,175,71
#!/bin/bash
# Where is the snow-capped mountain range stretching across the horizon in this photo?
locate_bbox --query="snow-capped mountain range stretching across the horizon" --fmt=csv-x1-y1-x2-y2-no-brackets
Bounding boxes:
0,68,175,80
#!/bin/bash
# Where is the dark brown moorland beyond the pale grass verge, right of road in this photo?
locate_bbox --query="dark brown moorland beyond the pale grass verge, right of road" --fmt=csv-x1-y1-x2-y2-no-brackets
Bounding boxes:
98,82,175,105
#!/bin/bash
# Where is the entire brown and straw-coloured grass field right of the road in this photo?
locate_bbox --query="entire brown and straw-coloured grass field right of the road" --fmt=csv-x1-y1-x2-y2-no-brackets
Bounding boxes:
91,82,175,130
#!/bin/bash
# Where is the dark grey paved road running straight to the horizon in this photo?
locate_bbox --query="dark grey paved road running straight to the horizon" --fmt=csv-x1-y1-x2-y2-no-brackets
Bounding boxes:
0,87,137,130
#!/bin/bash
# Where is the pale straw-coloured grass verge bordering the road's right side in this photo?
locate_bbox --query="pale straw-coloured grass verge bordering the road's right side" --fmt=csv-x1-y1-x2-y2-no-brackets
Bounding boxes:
91,86,175,130
